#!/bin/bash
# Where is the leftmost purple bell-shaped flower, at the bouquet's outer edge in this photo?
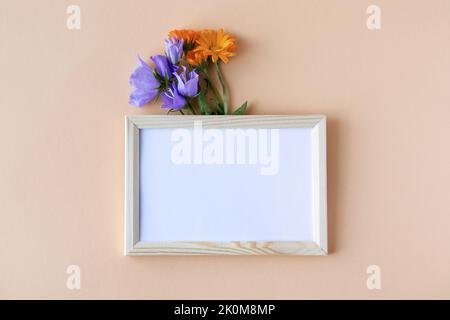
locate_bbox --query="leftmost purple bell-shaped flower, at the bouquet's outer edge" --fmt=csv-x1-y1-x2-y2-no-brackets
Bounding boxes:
130,56,160,107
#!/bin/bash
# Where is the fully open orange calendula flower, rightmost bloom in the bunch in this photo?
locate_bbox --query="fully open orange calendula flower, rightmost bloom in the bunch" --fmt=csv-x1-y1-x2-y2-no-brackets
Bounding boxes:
194,29,236,63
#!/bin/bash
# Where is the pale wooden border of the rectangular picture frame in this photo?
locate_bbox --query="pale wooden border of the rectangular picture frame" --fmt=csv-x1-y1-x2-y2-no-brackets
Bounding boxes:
125,115,328,255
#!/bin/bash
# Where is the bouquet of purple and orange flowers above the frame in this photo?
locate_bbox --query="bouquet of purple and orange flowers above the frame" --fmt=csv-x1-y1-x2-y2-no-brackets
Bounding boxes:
130,29,247,115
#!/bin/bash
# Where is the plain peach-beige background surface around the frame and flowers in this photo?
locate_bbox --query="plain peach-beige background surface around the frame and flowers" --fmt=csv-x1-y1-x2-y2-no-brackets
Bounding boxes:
0,0,450,299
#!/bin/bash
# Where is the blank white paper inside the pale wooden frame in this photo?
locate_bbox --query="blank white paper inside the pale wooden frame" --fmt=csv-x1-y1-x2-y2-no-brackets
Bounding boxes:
139,128,313,241
